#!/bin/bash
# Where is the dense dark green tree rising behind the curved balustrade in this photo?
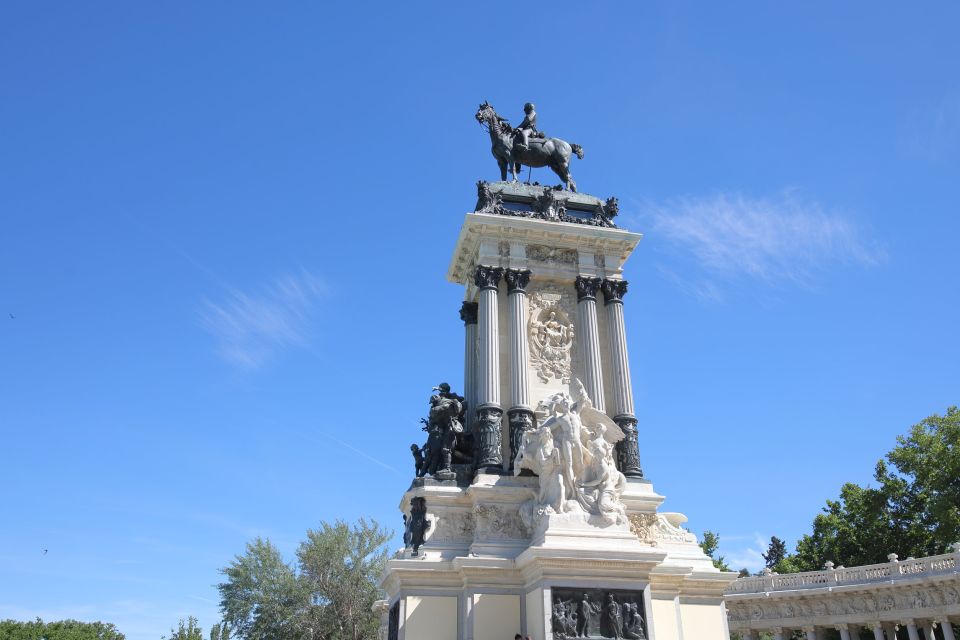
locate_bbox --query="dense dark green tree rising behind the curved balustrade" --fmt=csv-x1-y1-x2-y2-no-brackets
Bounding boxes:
789,407,960,571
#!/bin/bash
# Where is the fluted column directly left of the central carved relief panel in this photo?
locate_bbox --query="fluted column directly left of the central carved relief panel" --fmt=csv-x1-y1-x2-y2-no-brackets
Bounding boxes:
504,269,533,471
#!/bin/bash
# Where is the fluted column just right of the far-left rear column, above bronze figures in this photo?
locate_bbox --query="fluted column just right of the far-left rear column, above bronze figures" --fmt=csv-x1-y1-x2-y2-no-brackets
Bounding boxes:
473,265,503,473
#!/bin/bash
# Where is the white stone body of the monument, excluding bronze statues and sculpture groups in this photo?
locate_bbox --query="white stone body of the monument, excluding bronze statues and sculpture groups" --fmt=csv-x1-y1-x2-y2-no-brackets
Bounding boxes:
378,206,735,640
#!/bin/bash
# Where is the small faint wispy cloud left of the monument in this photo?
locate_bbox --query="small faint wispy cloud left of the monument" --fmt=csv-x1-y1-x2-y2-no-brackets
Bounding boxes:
200,270,326,369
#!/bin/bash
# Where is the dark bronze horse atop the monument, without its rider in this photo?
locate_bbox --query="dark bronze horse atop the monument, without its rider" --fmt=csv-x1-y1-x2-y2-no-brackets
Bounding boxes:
476,102,583,191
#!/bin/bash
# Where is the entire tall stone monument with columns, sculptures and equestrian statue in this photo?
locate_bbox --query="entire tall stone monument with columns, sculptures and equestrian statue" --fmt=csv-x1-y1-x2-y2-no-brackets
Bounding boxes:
377,104,736,640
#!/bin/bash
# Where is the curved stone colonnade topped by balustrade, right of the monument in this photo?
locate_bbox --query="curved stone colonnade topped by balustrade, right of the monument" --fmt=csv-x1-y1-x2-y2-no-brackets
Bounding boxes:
725,544,960,640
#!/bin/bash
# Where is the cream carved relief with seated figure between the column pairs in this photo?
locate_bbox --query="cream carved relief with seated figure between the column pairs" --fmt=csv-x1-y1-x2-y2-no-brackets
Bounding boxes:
527,286,575,384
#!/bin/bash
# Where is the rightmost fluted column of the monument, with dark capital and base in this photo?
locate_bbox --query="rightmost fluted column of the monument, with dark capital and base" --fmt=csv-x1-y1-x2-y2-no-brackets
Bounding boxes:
603,280,643,478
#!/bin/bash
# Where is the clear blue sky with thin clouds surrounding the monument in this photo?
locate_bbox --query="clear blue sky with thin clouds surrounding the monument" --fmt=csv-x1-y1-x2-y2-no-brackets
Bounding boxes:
0,2,960,640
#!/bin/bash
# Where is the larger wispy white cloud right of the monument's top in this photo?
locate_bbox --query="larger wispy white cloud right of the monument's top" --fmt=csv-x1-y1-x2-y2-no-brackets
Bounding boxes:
642,191,886,300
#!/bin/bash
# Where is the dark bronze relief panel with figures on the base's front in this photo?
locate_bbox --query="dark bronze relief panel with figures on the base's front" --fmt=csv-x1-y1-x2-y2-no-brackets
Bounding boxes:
550,587,647,640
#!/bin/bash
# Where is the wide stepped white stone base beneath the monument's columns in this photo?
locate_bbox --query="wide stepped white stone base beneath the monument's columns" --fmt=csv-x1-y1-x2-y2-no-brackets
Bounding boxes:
377,472,736,640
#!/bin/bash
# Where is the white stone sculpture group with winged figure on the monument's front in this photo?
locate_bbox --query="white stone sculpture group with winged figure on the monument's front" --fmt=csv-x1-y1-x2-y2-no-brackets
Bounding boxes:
513,380,627,529
